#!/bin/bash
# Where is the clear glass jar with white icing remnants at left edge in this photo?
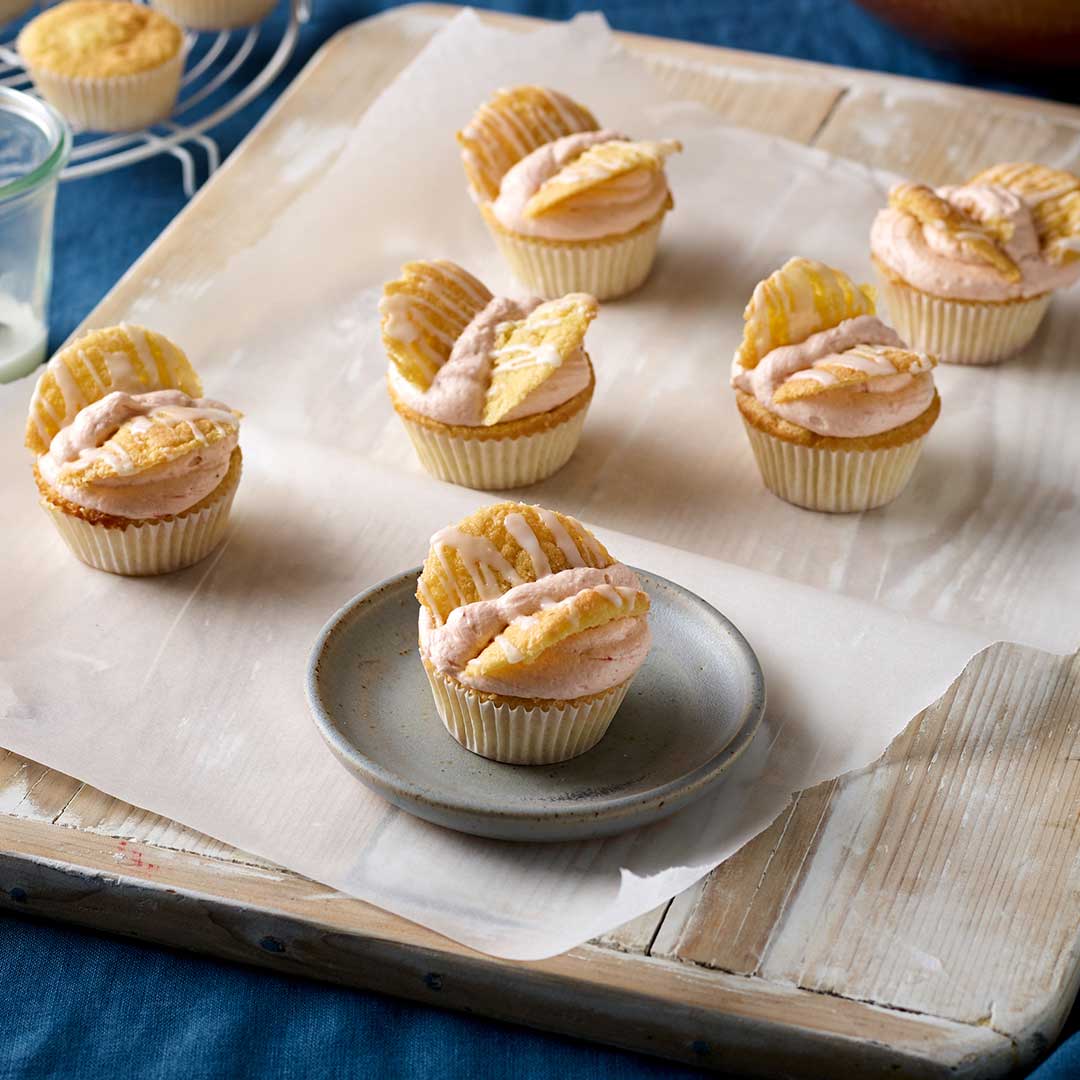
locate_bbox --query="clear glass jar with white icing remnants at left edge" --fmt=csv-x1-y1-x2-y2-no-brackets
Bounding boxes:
0,86,71,382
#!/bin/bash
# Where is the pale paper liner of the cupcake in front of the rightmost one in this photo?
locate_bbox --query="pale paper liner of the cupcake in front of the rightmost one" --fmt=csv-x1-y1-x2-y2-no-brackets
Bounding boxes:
743,417,926,514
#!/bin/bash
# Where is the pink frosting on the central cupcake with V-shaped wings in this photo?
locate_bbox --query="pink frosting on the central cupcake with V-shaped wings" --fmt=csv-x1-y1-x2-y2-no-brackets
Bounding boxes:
388,296,592,428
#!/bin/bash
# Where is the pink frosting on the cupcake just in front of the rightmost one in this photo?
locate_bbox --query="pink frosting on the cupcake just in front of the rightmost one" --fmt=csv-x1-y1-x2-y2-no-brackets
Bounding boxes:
731,315,934,438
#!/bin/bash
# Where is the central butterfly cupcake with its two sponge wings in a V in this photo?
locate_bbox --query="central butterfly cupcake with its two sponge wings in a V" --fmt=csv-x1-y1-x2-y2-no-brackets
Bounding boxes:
379,260,597,488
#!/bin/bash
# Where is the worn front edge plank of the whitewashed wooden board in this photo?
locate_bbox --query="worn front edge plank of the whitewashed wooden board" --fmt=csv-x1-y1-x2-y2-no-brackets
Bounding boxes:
0,818,1014,1078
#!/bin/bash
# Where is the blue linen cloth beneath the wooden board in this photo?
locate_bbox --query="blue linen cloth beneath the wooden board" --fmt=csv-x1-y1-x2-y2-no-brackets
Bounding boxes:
0,0,1080,1080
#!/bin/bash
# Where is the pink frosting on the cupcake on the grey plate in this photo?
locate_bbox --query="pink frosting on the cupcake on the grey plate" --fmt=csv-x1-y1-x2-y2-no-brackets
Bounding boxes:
420,563,651,700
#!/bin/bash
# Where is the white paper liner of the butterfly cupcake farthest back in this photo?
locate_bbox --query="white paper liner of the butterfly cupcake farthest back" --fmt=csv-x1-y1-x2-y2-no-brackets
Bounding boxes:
484,212,664,300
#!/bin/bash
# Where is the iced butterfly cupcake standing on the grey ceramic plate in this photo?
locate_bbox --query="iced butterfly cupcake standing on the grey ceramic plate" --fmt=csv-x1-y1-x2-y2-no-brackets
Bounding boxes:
417,502,650,765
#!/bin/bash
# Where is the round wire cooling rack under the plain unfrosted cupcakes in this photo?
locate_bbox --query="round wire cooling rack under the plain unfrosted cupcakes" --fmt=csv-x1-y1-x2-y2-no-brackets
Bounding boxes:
0,0,311,197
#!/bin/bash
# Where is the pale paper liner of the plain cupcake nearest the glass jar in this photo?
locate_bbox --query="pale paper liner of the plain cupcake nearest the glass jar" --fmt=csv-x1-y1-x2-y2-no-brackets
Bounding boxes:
29,50,184,132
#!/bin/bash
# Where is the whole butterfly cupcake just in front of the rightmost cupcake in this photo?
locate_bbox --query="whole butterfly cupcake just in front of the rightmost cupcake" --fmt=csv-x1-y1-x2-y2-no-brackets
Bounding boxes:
731,258,941,512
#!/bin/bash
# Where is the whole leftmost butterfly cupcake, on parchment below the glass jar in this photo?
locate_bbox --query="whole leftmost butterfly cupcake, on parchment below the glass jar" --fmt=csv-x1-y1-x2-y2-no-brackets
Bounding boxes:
26,325,241,576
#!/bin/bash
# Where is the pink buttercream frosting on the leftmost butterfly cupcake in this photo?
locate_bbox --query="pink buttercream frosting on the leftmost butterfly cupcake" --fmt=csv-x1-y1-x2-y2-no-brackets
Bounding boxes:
38,390,238,518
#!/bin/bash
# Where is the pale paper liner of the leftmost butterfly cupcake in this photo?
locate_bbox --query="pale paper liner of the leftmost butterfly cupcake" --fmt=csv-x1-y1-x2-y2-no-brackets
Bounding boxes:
41,460,240,577
